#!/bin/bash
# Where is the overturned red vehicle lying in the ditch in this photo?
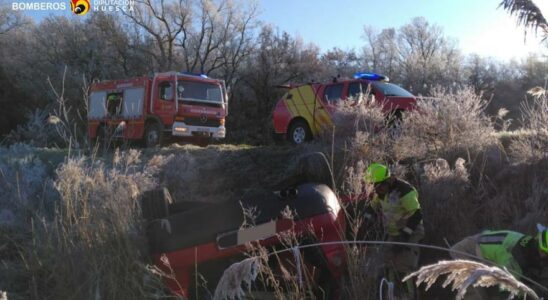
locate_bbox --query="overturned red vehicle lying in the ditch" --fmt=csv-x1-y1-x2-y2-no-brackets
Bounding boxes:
142,176,346,299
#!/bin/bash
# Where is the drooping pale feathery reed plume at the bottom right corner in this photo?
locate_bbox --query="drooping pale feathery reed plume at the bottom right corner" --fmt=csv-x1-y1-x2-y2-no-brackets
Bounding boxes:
403,260,540,300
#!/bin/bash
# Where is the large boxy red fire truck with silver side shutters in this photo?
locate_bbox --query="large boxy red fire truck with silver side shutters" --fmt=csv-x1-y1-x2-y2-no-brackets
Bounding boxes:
88,71,228,147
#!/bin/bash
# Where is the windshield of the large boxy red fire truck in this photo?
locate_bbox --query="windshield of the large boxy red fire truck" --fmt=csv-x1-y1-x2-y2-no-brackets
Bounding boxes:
177,80,223,104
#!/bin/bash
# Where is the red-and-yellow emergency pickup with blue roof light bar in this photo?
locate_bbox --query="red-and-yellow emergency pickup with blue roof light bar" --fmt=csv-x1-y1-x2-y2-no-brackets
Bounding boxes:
272,73,416,144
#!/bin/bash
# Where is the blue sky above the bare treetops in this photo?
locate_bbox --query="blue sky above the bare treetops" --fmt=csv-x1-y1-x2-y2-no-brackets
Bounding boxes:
8,0,548,59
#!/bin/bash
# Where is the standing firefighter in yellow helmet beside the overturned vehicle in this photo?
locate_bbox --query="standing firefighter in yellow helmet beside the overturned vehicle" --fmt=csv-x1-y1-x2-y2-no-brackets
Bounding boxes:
364,163,424,279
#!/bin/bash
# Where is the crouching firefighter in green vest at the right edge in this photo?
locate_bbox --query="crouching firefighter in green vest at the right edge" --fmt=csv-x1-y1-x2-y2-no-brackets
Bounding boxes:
450,224,548,299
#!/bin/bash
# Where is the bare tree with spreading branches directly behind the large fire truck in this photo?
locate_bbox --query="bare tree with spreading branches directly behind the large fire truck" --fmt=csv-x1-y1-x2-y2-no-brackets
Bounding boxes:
126,0,257,86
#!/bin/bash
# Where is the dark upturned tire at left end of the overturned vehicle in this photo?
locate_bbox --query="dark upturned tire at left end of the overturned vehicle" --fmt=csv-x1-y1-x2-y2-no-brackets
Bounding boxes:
141,188,173,222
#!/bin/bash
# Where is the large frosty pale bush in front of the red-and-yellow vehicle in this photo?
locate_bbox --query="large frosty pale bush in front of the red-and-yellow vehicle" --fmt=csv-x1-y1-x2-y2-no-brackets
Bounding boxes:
394,88,497,160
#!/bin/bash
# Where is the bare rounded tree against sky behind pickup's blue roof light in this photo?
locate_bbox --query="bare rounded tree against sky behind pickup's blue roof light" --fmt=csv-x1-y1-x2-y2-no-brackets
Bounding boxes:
363,18,463,94
